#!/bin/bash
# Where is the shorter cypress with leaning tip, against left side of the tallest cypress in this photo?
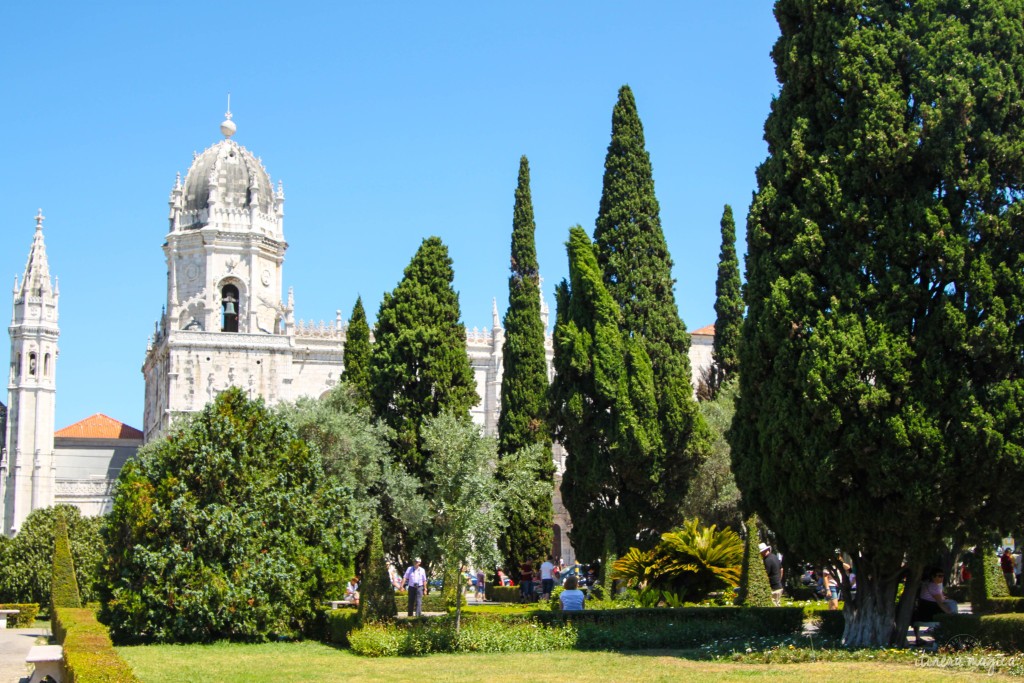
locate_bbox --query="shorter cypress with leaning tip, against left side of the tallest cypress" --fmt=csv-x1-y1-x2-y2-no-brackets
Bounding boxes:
551,225,663,561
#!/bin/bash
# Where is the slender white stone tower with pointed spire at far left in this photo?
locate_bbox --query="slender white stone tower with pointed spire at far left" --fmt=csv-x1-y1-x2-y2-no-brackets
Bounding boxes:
0,209,60,536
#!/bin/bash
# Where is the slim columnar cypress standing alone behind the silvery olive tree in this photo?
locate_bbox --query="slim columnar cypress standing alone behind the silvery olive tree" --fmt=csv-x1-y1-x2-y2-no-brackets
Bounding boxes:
498,157,554,582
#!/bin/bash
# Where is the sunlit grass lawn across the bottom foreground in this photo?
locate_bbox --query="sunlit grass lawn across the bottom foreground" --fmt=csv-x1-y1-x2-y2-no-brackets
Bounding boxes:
118,642,1000,683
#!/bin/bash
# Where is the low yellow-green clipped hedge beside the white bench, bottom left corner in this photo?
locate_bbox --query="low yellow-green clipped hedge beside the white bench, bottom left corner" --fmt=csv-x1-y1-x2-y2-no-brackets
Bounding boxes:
53,607,141,683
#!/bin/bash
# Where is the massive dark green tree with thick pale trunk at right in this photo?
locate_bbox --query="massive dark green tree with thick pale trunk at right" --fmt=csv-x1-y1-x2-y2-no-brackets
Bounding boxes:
730,0,1024,646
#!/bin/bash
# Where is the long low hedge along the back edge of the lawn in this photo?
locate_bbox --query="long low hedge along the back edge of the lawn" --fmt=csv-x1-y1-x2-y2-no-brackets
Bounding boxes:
348,607,804,656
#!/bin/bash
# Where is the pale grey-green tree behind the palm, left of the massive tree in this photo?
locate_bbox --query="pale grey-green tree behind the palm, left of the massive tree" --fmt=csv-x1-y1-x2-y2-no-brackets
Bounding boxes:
682,378,743,528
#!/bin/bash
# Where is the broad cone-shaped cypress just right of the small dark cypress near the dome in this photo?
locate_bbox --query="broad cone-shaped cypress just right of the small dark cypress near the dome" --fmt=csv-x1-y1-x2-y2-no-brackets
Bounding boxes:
370,237,480,482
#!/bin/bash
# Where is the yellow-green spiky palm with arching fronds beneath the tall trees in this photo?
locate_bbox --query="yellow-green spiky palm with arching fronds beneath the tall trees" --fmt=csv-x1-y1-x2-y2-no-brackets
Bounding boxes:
612,519,743,606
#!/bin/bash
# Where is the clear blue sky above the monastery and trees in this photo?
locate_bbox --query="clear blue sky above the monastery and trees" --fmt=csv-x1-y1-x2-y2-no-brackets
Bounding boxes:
0,0,778,428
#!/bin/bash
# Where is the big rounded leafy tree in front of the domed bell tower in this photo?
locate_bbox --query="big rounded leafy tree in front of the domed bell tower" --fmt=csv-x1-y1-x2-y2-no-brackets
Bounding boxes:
100,388,368,642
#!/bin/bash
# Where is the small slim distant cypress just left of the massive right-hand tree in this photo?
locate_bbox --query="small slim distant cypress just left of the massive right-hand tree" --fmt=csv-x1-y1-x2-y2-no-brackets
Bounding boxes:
711,204,743,394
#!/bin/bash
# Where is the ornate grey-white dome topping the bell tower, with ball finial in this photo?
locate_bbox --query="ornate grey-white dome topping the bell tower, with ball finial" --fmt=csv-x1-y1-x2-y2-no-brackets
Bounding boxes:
170,112,285,239
